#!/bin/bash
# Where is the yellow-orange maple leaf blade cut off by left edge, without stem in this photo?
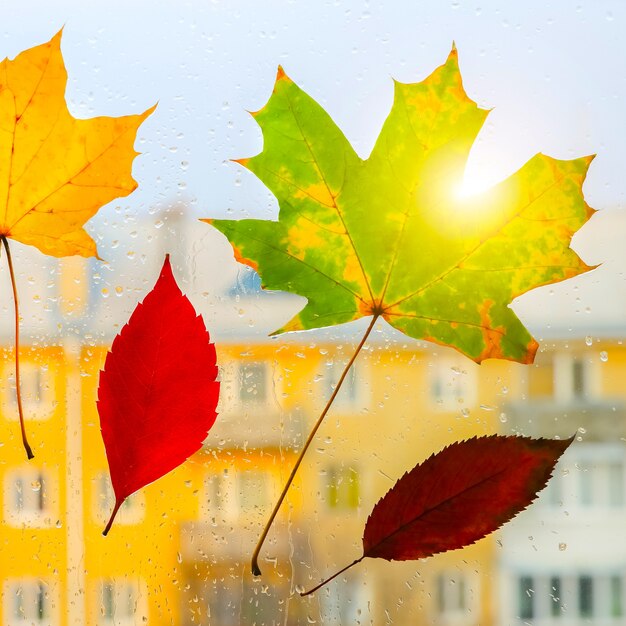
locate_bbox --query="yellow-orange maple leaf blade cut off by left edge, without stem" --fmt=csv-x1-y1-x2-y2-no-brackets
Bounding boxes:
0,31,154,257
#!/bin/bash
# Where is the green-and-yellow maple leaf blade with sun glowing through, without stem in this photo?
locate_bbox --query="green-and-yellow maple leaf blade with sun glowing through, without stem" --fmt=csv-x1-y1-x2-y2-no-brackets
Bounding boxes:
206,49,593,363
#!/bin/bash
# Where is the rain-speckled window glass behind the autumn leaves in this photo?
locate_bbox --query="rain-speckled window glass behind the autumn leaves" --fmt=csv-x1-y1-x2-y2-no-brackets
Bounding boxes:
0,0,626,626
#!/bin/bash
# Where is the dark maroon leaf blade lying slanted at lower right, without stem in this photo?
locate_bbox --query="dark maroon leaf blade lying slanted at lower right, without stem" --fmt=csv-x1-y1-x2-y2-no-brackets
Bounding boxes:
363,435,574,561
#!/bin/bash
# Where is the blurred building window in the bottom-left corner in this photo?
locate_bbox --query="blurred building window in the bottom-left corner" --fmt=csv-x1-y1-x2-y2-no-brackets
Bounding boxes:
2,580,53,626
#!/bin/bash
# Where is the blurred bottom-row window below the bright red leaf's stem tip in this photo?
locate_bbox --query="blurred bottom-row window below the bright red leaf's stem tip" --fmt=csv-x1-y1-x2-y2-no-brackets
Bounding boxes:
97,579,146,626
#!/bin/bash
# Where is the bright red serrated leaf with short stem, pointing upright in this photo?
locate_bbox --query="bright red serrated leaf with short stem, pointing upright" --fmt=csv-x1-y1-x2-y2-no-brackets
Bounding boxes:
98,255,219,535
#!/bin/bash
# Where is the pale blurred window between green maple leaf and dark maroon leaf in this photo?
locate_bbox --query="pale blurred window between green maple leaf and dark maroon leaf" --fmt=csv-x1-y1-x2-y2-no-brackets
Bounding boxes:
428,357,477,411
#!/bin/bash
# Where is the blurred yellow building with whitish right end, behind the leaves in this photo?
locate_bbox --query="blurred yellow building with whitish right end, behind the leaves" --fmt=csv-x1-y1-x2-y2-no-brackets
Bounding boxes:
0,251,626,626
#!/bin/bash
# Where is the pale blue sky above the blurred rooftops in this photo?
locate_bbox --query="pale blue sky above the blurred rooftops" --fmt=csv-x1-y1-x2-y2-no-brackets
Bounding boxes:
0,0,626,336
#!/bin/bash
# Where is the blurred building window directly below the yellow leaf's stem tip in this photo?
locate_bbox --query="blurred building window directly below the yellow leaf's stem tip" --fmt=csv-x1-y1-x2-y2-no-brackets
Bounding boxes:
4,467,56,527
